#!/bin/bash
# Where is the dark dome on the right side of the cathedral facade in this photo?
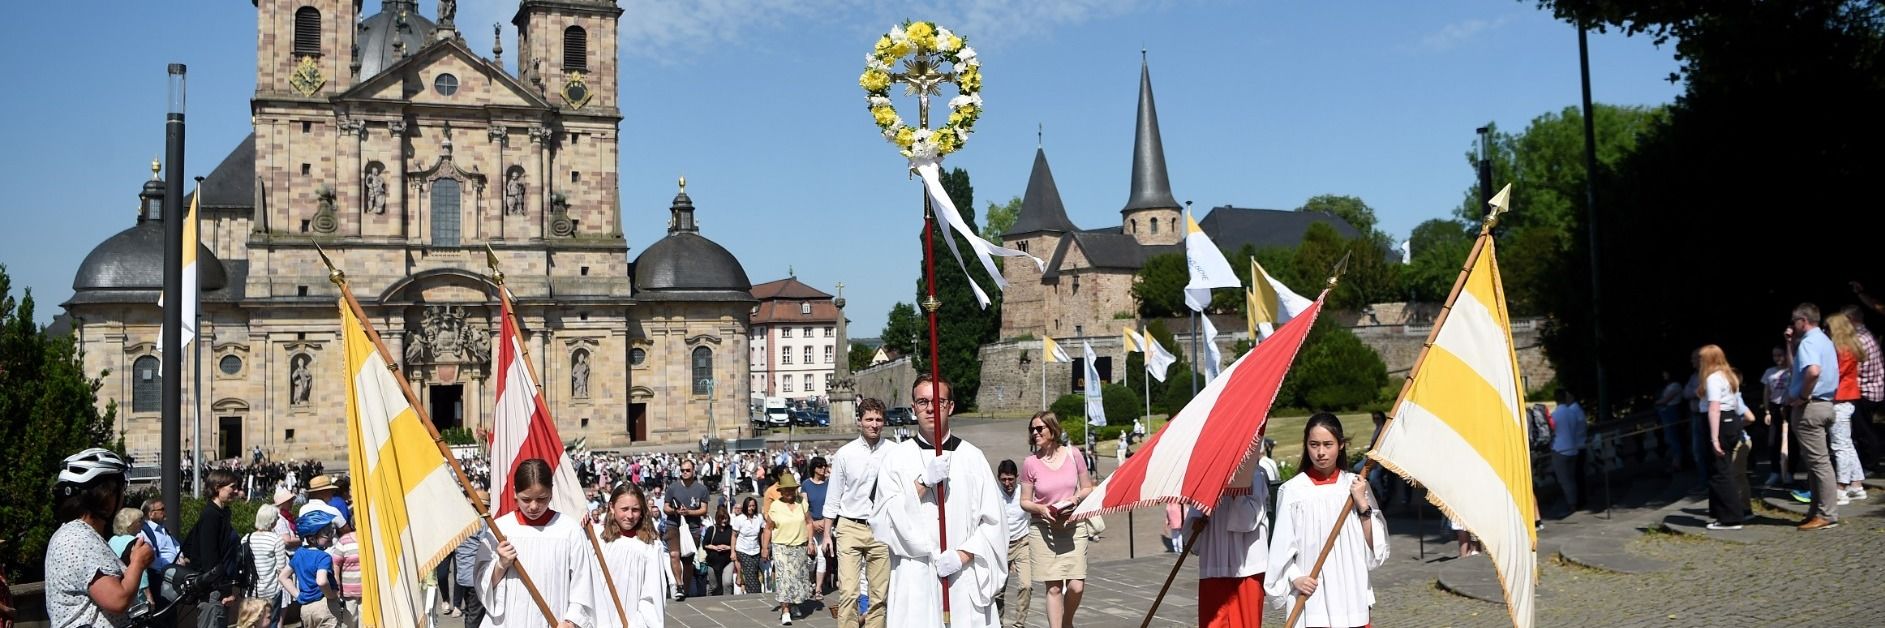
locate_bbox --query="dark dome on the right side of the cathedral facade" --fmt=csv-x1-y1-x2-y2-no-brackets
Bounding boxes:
635,183,752,302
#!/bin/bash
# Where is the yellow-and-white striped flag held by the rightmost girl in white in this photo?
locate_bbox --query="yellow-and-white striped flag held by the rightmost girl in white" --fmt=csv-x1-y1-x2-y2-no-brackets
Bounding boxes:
1369,234,1538,628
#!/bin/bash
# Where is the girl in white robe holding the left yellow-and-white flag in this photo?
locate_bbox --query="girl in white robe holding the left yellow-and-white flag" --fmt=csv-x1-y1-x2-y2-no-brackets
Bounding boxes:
477,458,596,628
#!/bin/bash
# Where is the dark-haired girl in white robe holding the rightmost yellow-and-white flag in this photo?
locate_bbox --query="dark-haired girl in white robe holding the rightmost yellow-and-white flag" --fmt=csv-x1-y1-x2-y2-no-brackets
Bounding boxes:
1263,413,1387,628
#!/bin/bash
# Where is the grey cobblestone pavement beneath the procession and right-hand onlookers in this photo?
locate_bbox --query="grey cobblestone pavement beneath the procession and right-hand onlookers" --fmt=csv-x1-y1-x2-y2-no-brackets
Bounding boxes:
439,414,1885,628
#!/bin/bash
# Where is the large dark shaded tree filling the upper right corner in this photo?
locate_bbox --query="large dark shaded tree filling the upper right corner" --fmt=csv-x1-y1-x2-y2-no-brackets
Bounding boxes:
1530,0,1885,403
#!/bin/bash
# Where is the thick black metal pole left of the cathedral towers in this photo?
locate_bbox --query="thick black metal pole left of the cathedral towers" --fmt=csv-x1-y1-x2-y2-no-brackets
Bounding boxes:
160,64,187,516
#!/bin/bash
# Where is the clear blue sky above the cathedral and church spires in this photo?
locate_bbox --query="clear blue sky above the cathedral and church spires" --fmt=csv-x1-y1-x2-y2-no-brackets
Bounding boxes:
0,0,1680,336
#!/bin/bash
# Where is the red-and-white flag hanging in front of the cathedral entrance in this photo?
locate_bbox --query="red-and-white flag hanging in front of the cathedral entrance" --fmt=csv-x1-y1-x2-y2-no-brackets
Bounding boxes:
490,287,588,517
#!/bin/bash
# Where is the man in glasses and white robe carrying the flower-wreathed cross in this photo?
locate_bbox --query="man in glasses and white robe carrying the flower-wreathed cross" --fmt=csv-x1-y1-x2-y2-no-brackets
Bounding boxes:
871,375,1008,628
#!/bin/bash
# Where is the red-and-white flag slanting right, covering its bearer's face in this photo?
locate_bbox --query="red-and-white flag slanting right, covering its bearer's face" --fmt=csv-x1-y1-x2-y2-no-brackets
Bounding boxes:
1073,292,1329,519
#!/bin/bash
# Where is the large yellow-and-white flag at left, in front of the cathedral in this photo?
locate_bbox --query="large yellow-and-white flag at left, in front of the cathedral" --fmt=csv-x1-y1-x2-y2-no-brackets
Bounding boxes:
341,296,479,628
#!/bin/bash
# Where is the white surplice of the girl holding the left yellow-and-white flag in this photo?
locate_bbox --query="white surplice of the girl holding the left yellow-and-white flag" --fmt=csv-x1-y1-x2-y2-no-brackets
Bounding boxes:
477,513,596,628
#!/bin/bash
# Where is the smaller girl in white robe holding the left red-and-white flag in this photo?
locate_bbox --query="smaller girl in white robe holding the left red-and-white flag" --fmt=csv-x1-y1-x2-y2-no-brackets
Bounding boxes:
590,481,667,628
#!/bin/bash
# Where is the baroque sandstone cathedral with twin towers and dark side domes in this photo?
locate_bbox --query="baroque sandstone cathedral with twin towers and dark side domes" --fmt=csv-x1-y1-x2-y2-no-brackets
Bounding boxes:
64,0,756,460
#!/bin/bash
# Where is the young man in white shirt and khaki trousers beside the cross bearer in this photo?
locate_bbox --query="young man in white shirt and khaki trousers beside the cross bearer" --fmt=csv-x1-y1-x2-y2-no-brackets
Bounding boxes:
822,398,890,628
